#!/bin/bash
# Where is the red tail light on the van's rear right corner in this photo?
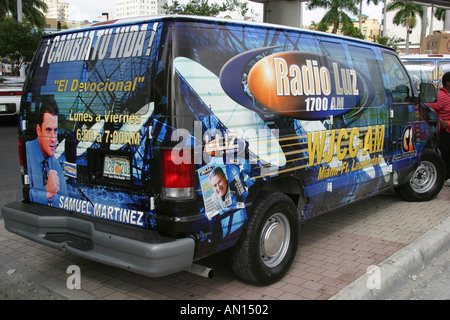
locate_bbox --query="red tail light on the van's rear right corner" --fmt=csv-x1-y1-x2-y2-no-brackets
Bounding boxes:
161,149,195,200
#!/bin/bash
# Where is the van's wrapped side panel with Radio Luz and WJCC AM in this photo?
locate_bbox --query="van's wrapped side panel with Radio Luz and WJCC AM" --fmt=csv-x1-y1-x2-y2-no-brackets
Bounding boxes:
164,20,426,254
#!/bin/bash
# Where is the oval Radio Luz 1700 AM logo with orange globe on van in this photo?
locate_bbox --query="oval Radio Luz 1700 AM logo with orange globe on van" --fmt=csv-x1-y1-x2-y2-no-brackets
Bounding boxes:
220,47,374,120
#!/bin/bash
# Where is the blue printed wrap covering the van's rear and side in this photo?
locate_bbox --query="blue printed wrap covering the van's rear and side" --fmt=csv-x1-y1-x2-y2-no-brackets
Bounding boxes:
21,18,432,258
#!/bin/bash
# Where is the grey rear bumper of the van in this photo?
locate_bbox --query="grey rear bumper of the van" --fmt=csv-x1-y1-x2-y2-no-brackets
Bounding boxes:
2,202,195,277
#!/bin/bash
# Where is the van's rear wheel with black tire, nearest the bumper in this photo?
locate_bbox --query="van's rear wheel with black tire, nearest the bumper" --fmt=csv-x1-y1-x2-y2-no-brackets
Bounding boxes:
231,193,299,285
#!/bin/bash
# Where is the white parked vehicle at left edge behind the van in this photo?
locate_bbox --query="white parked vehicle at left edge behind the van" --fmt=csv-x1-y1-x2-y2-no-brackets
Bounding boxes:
0,76,24,117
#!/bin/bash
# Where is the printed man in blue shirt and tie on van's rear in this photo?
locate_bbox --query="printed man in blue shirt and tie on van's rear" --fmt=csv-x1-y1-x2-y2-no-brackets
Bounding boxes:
27,102,67,206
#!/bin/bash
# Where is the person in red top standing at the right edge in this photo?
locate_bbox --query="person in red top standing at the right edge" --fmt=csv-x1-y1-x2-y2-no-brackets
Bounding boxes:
429,72,450,185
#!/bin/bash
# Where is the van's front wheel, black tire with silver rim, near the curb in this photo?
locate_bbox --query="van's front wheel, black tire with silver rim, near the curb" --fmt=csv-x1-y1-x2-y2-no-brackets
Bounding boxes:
395,150,445,202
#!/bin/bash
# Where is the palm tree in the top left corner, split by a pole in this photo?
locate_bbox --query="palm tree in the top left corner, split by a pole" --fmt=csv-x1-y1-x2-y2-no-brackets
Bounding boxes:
0,0,47,28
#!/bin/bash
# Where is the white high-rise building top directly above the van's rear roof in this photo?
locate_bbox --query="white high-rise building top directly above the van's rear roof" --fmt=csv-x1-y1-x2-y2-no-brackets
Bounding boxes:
115,0,167,19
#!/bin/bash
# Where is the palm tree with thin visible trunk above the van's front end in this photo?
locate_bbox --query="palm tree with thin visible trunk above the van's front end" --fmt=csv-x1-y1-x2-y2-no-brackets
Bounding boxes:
386,1,423,54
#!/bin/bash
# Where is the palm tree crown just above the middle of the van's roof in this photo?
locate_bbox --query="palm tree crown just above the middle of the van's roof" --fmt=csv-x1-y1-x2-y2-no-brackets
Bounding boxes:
307,0,358,33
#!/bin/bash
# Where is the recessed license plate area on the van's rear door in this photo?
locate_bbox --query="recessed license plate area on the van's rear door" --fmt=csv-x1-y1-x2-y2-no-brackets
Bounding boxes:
87,149,133,187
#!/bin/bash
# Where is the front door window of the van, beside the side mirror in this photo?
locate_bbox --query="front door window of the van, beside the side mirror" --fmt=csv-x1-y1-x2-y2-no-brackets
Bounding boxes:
383,52,412,103
